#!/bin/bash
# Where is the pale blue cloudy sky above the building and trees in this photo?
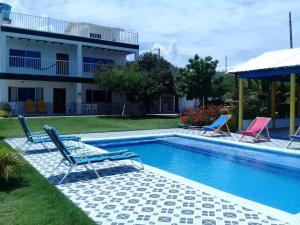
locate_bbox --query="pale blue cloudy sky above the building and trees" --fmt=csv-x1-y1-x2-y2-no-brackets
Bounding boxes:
6,0,300,70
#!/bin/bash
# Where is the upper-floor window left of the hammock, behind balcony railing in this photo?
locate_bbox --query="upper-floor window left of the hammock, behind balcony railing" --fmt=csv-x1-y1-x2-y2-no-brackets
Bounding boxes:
9,49,41,69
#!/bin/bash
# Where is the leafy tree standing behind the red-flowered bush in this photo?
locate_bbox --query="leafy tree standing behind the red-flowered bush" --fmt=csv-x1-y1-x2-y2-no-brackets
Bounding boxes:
176,55,218,105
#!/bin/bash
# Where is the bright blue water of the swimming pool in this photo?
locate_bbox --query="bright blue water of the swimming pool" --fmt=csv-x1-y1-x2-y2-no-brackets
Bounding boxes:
89,137,300,213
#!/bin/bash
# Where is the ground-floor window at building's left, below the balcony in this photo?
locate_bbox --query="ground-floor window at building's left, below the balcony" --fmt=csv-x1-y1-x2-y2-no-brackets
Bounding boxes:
8,87,44,102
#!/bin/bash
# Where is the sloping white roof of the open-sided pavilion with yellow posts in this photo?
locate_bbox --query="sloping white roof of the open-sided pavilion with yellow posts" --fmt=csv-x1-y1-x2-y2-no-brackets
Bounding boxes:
228,48,300,74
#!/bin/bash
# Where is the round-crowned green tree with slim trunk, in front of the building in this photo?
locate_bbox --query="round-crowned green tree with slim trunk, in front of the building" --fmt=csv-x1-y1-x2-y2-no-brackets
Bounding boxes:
94,64,149,116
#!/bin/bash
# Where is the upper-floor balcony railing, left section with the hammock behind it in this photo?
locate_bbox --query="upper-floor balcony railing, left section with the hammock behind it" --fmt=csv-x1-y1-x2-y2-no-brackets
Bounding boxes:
8,56,77,76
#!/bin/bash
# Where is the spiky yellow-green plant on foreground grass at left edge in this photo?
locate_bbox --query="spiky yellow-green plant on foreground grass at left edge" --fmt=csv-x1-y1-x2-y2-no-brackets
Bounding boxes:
0,148,22,184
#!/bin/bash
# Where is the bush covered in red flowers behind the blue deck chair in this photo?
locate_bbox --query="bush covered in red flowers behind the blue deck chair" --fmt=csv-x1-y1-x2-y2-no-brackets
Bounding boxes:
180,105,237,131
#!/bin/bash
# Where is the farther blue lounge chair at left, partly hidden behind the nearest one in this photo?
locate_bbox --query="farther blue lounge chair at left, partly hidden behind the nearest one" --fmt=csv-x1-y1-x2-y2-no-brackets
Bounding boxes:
18,115,80,151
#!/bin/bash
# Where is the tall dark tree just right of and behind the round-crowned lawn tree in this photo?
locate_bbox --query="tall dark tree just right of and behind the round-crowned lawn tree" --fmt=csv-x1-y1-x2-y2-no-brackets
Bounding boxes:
137,53,176,111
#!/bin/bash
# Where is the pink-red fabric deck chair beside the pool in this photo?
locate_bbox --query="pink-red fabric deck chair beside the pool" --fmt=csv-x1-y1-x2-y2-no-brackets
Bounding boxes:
239,117,271,142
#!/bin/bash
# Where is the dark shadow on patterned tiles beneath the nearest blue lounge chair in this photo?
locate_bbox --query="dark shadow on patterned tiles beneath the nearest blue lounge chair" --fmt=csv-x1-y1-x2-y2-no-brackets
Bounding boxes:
48,165,139,185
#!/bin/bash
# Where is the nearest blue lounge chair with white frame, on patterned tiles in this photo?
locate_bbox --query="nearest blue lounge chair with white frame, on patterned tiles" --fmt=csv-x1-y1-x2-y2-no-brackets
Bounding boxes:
44,126,144,184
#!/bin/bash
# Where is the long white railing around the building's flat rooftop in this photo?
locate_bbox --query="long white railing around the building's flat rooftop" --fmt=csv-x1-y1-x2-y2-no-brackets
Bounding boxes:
0,11,138,45
